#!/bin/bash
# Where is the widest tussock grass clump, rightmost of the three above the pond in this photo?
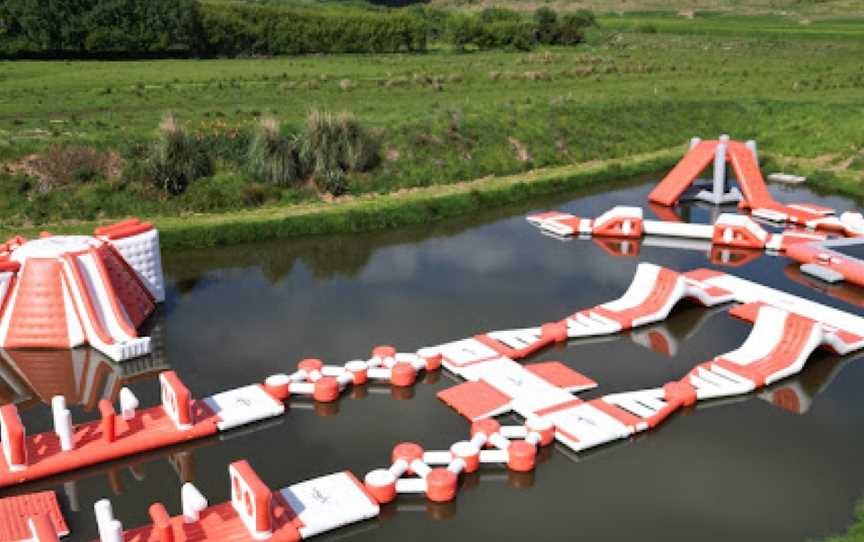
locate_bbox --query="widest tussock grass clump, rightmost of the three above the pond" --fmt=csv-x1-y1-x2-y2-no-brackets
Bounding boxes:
300,110,381,196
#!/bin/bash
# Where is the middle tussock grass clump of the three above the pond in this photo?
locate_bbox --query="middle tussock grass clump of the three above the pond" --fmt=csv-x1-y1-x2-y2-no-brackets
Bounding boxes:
248,117,303,186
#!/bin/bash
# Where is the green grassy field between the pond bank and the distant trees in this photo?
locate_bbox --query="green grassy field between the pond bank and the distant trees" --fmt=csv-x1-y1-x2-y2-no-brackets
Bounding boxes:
0,14,864,228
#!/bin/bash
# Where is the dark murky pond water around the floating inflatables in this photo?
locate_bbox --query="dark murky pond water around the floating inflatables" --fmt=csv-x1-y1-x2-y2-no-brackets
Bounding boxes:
0,177,864,542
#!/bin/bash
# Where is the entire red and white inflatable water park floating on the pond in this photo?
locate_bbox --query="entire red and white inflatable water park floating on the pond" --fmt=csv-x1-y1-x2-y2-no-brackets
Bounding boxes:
0,136,864,542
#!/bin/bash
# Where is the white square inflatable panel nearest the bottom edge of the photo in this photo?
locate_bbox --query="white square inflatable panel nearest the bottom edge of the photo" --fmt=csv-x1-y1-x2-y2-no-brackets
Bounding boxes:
279,471,379,538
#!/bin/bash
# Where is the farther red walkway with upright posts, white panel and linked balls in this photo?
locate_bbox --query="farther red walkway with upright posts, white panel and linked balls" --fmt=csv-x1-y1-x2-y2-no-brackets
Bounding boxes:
0,346,441,487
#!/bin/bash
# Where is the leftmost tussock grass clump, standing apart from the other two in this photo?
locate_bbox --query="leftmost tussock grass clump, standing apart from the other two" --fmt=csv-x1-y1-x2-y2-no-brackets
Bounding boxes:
147,114,213,195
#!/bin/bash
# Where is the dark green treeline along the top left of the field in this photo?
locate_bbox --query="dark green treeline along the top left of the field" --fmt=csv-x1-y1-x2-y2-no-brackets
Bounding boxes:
0,0,594,58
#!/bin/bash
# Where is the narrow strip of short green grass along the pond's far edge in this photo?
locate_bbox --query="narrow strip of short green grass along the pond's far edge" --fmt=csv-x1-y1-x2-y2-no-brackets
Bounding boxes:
0,148,682,248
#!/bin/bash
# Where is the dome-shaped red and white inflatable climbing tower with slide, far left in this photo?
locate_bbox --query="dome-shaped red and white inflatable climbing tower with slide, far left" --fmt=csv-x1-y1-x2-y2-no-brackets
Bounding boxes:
0,219,165,361
